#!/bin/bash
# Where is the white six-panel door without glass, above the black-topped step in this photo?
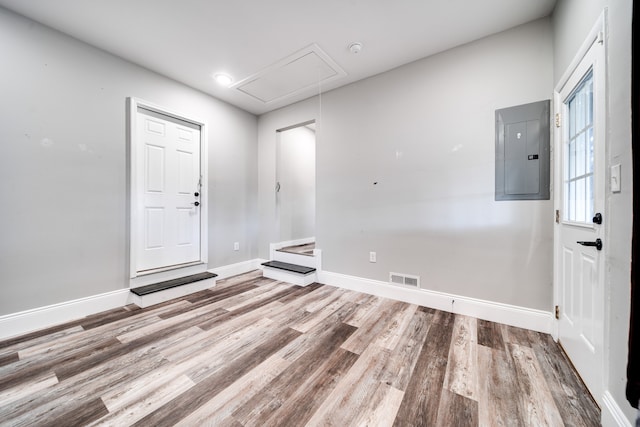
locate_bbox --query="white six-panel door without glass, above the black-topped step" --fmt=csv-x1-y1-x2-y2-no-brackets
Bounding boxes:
132,107,202,273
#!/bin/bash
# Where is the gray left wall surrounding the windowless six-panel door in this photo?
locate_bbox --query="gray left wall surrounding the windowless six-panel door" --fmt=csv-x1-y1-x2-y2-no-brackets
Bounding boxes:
0,8,257,315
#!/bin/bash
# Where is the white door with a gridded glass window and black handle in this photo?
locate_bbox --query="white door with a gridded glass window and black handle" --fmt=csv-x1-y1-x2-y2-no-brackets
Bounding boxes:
556,24,608,402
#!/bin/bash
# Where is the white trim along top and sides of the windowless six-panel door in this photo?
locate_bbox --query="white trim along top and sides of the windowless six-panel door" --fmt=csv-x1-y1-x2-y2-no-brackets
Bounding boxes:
127,97,209,279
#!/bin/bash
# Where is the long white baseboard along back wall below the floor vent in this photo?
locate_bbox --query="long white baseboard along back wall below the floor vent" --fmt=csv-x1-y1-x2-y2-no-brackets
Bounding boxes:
318,271,553,334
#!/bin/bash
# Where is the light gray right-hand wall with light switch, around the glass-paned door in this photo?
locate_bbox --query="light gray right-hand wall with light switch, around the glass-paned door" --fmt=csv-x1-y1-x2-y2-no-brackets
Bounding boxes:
553,0,634,419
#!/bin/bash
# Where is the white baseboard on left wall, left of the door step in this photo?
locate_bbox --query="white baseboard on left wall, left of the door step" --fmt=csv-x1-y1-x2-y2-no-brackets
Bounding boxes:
0,288,132,339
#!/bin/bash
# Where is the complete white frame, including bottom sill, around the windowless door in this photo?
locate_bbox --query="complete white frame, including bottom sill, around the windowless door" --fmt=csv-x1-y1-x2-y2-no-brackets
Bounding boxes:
127,97,209,282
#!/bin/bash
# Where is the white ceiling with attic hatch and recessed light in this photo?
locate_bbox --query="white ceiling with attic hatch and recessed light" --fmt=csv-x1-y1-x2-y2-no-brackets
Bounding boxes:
0,0,556,114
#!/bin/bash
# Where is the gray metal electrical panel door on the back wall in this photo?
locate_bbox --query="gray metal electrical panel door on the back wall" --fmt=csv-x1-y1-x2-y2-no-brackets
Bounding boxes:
496,100,551,200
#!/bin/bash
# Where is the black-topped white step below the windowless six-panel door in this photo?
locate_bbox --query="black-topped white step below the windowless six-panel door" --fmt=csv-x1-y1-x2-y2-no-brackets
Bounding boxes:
130,272,218,308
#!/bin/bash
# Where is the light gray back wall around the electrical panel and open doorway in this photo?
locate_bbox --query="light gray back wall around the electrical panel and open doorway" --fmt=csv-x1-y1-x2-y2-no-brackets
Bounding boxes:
258,19,553,311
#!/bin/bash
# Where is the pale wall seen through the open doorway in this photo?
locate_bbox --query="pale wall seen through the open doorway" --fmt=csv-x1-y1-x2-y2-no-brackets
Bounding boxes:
276,126,316,242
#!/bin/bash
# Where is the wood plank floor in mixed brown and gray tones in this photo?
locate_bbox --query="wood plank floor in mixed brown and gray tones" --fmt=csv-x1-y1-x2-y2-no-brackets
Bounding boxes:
0,272,600,427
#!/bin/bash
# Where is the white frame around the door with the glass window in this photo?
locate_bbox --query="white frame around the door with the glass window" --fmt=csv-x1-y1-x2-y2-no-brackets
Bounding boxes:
552,8,610,407
